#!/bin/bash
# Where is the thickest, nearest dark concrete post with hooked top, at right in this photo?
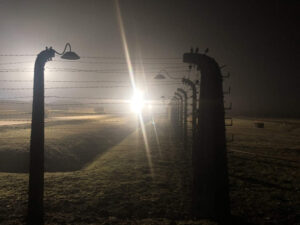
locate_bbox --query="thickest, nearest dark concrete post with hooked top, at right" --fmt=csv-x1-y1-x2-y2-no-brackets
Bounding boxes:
183,48,230,221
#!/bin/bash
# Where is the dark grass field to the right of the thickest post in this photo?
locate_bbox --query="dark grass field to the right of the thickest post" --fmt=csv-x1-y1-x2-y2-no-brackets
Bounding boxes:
228,119,300,224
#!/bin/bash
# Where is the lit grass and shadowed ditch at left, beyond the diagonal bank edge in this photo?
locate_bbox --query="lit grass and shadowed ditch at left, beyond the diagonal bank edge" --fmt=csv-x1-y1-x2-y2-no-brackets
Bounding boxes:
0,115,135,172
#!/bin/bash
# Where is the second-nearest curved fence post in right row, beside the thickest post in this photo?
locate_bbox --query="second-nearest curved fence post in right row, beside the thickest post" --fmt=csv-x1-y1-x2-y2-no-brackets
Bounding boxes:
182,78,198,155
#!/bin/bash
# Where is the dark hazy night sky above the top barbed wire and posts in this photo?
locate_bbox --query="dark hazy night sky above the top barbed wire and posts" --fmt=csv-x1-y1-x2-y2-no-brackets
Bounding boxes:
0,0,300,116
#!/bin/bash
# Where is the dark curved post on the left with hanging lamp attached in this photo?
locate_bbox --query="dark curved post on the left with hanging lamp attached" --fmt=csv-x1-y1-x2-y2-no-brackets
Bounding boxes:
28,43,80,225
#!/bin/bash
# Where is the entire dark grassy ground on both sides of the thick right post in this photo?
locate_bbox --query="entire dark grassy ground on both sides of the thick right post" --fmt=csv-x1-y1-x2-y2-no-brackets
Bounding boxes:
0,115,300,225
